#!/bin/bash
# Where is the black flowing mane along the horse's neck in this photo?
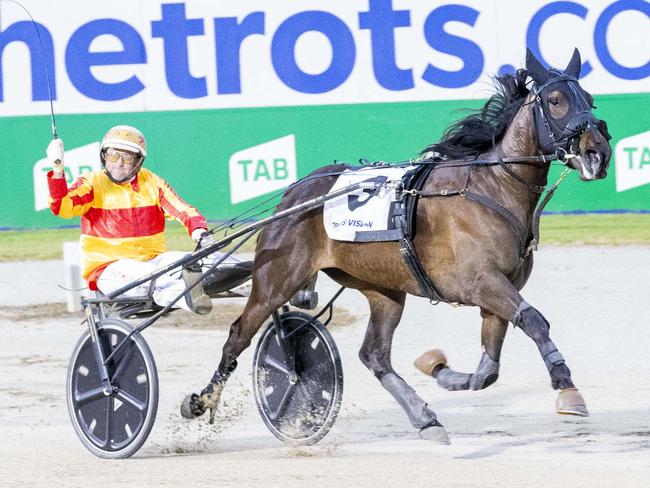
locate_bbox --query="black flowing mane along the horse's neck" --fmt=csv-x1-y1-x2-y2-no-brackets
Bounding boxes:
422,69,530,159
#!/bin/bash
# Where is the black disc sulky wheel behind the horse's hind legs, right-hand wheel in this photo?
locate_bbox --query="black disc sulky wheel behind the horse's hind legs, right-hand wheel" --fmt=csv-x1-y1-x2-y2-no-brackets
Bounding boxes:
253,312,343,445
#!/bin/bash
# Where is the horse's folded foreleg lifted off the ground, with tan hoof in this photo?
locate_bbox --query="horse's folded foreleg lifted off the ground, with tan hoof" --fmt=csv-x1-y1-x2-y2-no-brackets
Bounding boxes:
415,309,508,391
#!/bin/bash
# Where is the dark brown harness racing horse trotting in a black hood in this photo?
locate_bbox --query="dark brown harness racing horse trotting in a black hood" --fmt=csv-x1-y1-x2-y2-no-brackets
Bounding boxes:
183,50,611,443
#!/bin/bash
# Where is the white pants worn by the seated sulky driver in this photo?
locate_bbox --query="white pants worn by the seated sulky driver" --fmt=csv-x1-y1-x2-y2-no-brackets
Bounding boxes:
97,251,194,310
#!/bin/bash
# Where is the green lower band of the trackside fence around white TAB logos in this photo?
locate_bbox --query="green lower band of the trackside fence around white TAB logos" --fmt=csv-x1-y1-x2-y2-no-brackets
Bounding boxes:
0,94,650,228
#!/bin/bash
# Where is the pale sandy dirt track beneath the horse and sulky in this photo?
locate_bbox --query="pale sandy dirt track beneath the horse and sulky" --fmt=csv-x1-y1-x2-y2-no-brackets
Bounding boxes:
0,247,650,488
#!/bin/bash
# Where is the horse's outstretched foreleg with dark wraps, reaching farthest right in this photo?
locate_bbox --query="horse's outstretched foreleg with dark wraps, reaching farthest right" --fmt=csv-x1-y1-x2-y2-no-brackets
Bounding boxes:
472,275,587,415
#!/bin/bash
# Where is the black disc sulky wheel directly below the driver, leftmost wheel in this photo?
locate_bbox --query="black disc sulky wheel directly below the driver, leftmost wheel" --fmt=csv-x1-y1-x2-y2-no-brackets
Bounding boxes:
66,319,158,459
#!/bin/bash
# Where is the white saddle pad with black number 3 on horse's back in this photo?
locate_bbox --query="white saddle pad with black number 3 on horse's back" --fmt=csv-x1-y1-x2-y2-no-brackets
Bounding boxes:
323,166,415,242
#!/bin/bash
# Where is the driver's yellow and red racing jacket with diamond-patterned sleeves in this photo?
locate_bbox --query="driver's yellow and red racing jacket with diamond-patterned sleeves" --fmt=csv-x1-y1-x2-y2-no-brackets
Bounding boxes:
47,168,207,289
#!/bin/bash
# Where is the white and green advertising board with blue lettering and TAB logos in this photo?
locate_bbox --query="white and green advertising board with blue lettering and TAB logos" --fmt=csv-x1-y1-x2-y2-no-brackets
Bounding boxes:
0,0,650,228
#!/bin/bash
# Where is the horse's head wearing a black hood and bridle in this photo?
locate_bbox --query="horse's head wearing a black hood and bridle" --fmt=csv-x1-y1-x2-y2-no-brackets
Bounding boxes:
526,49,612,181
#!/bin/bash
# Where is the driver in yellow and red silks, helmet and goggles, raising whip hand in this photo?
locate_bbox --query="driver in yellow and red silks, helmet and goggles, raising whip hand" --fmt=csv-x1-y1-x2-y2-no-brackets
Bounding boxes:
47,125,213,315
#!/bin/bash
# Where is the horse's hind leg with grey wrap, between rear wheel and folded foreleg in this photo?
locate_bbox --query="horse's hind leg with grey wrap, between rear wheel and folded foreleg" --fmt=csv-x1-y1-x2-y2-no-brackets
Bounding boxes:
359,290,449,444
